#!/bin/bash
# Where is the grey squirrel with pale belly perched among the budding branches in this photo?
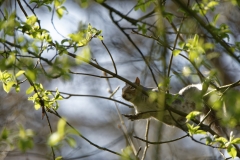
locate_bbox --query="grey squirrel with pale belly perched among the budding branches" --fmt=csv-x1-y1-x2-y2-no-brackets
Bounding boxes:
122,77,226,137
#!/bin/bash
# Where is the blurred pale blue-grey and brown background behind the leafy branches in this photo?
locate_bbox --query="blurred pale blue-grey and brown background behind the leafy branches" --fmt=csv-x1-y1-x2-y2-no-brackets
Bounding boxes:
0,0,240,160
